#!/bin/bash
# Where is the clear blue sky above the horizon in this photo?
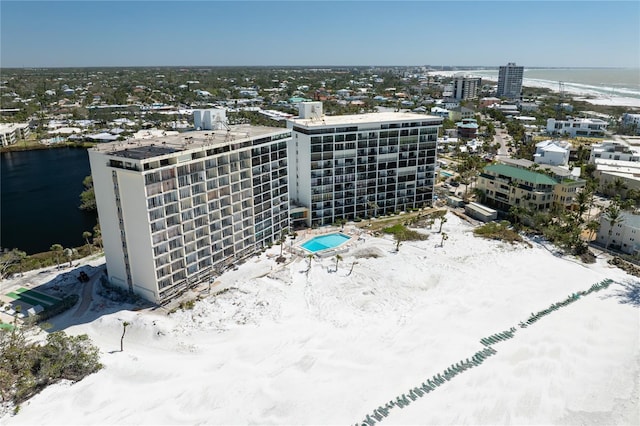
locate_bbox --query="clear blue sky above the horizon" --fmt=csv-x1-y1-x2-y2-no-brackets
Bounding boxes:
0,0,640,67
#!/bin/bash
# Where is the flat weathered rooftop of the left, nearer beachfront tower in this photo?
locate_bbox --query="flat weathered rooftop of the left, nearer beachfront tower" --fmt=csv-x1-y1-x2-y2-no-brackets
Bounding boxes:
92,125,289,160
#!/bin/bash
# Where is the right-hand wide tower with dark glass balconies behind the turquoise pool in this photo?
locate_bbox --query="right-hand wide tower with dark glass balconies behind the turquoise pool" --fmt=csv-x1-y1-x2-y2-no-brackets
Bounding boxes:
287,102,442,226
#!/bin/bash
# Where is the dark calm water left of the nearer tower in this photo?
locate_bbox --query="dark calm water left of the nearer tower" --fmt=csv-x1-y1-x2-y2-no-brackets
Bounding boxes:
0,148,97,254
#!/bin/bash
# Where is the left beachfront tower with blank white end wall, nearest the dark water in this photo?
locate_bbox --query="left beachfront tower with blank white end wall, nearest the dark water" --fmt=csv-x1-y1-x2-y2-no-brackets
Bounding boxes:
89,126,291,303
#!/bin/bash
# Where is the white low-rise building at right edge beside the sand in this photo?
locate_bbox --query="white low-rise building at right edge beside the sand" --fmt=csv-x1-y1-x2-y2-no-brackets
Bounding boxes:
596,211,640,256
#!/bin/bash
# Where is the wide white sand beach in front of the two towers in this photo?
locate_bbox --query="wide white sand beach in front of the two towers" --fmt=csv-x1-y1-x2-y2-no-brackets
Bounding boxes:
0,214,640,425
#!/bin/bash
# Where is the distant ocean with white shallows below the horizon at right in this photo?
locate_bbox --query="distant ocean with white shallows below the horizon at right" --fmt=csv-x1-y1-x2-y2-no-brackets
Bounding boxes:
466,68,640,99
